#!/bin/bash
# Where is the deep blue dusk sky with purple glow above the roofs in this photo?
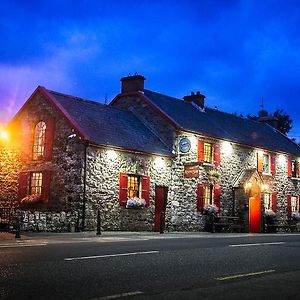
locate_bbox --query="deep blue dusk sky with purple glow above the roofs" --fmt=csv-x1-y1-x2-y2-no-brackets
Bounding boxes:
0,0,300,141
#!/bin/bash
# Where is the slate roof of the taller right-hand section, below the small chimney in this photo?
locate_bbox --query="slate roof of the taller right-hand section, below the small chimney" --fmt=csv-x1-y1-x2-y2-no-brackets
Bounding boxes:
144,89,300,156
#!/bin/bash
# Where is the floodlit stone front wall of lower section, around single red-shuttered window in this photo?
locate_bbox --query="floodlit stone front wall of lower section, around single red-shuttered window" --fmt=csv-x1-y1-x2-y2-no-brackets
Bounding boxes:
85,147,171,231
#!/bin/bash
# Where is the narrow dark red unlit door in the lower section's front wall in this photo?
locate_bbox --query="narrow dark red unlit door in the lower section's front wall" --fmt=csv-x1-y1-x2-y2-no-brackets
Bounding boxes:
154,186,168,232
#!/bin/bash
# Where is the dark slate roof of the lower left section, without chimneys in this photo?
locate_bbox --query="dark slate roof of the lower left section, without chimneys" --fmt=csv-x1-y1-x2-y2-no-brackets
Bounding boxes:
47,90,171,155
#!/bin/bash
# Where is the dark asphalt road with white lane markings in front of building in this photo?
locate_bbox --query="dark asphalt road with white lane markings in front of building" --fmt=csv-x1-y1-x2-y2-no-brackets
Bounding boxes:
0,234,300,300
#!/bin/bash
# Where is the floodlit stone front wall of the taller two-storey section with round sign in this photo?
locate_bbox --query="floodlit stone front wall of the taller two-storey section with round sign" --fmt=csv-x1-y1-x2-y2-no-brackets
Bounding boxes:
167,132,300,230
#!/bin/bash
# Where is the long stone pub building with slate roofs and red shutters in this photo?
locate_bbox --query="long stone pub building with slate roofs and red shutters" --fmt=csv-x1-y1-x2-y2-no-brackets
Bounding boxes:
0,75,300,232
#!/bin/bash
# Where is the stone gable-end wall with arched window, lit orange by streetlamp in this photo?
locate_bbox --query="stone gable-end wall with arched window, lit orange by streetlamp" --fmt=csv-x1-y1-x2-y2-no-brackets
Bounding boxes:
1,94,85,231
